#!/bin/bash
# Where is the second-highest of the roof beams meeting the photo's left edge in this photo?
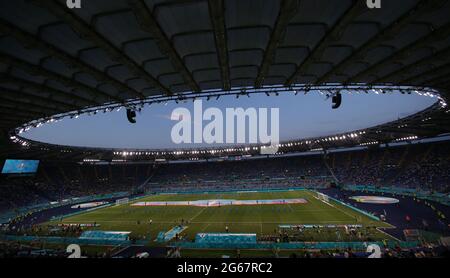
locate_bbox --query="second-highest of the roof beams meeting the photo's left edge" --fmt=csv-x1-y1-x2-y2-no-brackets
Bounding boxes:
0,53,122,102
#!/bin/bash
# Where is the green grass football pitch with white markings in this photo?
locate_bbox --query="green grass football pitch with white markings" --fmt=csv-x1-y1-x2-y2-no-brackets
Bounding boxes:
45,190,390,241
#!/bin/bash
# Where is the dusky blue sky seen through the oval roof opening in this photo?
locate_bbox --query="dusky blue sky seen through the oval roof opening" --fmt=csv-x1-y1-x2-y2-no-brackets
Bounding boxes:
22,92,436,149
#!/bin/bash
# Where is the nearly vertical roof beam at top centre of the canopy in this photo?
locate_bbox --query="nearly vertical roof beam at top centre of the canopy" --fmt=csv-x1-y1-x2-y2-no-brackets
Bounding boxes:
208,0,231,91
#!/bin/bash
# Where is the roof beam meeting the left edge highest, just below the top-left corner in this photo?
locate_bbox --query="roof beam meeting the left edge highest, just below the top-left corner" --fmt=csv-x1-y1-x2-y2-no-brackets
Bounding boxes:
0,19,141,102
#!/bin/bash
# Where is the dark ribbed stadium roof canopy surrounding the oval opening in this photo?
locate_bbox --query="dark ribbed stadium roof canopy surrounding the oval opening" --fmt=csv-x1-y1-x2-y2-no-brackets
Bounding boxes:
0,0,450,161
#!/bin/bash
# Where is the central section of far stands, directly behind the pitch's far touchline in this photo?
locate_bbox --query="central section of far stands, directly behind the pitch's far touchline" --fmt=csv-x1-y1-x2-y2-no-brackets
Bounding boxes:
147,155,332,191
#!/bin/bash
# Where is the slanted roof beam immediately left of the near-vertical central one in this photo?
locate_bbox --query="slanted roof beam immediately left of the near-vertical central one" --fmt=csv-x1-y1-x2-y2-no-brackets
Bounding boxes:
128,0,200,92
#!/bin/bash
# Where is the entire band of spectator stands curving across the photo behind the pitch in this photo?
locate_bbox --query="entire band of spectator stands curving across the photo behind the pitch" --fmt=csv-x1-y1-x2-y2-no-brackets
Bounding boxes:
0,142,450,211
